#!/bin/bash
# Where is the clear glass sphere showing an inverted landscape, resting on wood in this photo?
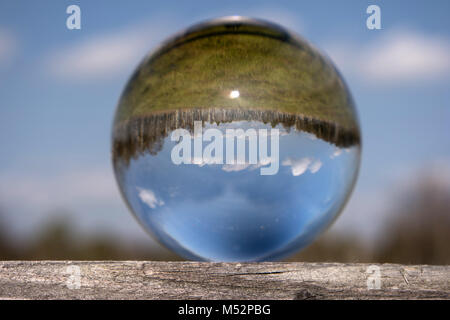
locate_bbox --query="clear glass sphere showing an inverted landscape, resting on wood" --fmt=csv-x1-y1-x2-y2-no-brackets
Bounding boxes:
112,17,360,261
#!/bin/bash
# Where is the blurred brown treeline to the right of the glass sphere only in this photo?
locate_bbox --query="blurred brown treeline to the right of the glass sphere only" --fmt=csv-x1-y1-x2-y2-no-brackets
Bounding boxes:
290,176,450,265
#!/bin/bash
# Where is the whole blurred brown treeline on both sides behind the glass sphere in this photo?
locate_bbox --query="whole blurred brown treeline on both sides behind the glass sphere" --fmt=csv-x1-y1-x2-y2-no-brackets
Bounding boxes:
0,174,450,264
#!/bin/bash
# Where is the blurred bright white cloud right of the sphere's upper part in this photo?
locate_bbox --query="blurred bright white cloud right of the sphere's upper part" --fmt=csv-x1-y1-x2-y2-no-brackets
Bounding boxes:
325,30,450,84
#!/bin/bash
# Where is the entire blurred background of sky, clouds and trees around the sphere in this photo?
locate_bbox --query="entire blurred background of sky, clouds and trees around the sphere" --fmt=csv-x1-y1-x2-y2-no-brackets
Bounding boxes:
0,0,450,264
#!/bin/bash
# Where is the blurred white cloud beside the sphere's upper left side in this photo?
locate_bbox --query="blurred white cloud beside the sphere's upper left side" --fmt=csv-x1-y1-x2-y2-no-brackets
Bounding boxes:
45,20,170,80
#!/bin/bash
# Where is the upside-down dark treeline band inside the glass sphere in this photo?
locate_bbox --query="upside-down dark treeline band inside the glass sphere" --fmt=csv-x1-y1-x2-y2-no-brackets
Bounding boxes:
113,108,360,164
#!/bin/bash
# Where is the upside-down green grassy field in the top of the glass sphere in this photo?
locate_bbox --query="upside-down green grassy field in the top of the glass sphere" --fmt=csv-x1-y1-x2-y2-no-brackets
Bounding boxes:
116,24,358,130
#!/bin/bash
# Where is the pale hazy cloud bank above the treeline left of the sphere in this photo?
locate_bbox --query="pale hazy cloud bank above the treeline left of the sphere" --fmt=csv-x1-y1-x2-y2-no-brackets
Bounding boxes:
0,170,160,246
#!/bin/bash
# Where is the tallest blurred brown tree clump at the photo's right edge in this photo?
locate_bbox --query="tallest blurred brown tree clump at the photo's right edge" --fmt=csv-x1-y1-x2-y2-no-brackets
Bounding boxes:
375,177,450,264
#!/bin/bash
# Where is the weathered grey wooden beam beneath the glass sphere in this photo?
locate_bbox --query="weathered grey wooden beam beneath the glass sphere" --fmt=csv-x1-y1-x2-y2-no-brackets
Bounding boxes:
0,261,450,299
